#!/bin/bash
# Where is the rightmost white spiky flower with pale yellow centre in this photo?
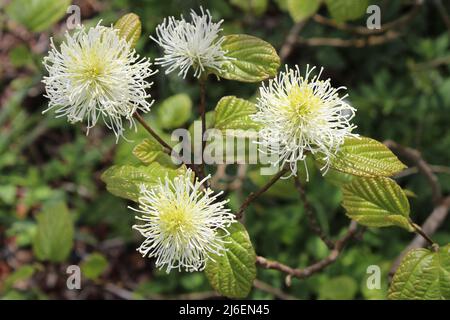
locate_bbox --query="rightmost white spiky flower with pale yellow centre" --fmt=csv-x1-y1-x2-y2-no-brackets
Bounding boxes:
252,65,356,175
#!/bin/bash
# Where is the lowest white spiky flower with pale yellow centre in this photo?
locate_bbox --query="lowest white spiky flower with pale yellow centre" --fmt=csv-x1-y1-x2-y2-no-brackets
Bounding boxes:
130,169,235,273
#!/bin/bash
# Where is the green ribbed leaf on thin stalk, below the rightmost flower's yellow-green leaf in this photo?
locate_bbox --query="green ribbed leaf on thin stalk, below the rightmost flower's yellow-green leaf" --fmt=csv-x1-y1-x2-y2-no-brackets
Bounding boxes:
342,177,413,231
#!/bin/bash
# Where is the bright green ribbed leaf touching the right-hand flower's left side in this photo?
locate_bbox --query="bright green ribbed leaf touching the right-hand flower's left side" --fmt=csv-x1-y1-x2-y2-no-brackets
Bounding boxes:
214,96,260,130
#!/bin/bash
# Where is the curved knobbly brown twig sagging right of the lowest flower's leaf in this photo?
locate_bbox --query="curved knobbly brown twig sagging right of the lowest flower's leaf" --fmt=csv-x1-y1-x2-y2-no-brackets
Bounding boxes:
256,221,358,279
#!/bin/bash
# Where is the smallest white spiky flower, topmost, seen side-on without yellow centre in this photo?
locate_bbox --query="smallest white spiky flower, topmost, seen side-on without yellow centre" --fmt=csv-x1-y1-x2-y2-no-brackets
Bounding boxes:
150,8,230,78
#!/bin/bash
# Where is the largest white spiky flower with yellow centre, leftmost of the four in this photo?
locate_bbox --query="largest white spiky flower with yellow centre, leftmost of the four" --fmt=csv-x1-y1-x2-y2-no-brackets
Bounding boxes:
43,25,154,138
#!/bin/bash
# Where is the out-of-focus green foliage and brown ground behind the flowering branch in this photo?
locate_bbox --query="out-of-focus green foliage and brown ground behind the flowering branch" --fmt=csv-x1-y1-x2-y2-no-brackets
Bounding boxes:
0,0,450,299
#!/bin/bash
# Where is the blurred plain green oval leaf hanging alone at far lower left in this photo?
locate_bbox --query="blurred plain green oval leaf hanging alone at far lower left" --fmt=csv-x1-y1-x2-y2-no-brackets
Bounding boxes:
33,202,74,262
